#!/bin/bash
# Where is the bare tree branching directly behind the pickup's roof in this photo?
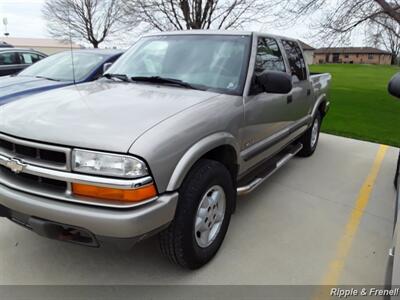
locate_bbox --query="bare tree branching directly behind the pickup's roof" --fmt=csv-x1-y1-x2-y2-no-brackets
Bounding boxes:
126,0,279,31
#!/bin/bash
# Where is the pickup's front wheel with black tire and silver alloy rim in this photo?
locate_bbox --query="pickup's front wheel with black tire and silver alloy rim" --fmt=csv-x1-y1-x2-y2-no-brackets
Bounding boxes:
159,159,236,269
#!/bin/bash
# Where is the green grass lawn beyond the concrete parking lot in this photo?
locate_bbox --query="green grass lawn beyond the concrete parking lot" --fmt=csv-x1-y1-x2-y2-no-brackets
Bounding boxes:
310,64,400,147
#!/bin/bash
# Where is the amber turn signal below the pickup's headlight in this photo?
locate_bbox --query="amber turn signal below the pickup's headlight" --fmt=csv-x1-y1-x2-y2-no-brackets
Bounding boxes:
72,183,157,202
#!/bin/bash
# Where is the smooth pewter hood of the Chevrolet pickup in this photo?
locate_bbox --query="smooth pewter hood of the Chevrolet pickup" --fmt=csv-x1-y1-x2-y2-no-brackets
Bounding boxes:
0,81,217,153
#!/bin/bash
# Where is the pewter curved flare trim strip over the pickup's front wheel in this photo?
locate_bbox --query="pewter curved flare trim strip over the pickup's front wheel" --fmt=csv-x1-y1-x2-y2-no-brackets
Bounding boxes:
167,132,240,191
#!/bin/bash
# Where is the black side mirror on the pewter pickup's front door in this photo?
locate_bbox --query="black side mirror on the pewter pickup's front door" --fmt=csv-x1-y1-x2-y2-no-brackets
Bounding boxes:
256,71,293,94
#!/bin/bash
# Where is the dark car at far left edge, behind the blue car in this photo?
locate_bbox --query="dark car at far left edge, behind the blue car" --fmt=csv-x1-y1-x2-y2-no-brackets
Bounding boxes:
0,44,47,76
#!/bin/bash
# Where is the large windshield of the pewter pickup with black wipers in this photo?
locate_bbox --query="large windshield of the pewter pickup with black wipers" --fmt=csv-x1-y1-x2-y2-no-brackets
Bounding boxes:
107,35,250,94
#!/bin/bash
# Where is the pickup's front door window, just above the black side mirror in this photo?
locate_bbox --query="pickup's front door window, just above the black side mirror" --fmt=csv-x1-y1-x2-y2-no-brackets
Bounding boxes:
255,38,286,74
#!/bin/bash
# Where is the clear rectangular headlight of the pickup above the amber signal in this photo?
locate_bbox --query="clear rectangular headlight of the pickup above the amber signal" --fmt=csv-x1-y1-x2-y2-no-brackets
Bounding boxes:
72,150,149,178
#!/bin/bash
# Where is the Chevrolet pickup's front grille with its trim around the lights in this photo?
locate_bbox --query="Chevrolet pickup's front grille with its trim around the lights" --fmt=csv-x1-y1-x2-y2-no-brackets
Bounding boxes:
0,133,157,208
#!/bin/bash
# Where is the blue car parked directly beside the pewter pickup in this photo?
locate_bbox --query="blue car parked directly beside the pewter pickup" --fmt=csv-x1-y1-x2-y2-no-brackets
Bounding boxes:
0,50,122,105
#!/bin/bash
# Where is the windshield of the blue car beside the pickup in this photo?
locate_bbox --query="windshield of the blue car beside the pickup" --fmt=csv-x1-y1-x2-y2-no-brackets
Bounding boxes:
18,51,106,81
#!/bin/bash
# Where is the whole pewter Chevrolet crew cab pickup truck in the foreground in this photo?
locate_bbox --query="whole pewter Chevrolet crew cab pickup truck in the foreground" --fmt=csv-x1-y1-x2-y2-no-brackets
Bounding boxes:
0,31,331,269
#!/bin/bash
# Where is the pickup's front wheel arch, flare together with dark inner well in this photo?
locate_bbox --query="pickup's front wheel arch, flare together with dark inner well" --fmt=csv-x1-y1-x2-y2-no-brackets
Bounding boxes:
166,132,239,191
